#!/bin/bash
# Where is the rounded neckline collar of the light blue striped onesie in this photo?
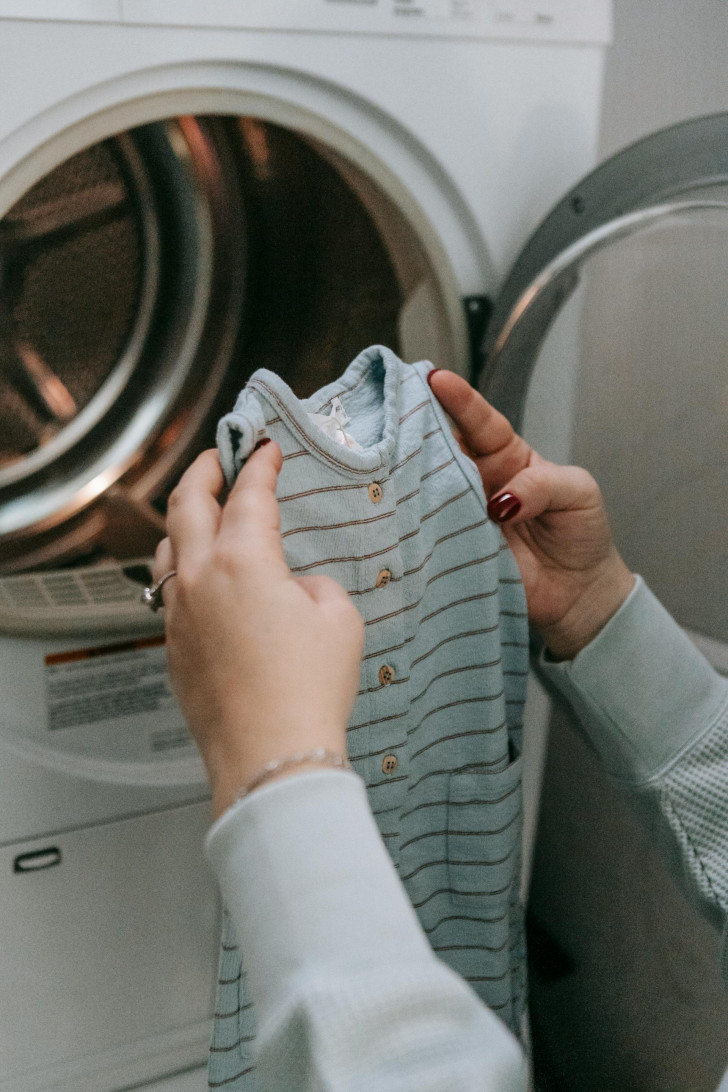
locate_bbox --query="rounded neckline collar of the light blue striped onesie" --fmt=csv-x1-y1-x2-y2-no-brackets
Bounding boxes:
247,345,404,475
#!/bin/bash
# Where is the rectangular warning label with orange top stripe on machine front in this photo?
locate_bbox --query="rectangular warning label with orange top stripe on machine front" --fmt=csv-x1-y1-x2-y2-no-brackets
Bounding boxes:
45,637,182,749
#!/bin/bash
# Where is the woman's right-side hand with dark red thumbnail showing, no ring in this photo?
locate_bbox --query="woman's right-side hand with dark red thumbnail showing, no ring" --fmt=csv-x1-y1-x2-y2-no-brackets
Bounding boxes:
430,370,634,660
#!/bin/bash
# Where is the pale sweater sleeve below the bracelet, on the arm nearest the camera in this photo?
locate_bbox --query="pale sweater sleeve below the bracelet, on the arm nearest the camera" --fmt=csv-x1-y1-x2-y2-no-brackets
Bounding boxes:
201,771,527,1092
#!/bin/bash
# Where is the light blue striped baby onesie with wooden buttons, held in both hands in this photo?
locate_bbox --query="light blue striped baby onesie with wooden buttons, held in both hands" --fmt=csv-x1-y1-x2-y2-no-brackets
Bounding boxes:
210,346,528,1090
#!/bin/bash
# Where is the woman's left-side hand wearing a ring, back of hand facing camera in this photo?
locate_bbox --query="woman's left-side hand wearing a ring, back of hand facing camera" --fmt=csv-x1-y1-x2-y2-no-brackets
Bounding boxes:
154,443,363,815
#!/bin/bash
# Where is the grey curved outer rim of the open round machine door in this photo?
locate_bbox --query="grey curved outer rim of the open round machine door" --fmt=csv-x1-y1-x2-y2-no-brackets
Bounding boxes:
476,114,728,429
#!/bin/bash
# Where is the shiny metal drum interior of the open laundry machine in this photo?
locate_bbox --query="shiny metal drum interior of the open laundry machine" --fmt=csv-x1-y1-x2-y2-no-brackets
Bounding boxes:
0,117,402,573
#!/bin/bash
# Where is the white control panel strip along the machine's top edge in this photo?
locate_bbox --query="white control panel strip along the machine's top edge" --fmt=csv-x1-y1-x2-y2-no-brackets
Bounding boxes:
0,0,611,44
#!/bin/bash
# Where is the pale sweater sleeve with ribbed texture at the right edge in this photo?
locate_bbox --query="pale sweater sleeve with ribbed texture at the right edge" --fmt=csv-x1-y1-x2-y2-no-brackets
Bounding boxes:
537,578,728,943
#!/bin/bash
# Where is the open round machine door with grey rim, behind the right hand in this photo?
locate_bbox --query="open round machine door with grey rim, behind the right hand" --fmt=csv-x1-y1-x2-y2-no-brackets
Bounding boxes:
480,114,728,655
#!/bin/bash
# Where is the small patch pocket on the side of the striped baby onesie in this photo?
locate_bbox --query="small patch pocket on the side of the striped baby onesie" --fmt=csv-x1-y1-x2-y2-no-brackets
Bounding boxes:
447,758,523,911
